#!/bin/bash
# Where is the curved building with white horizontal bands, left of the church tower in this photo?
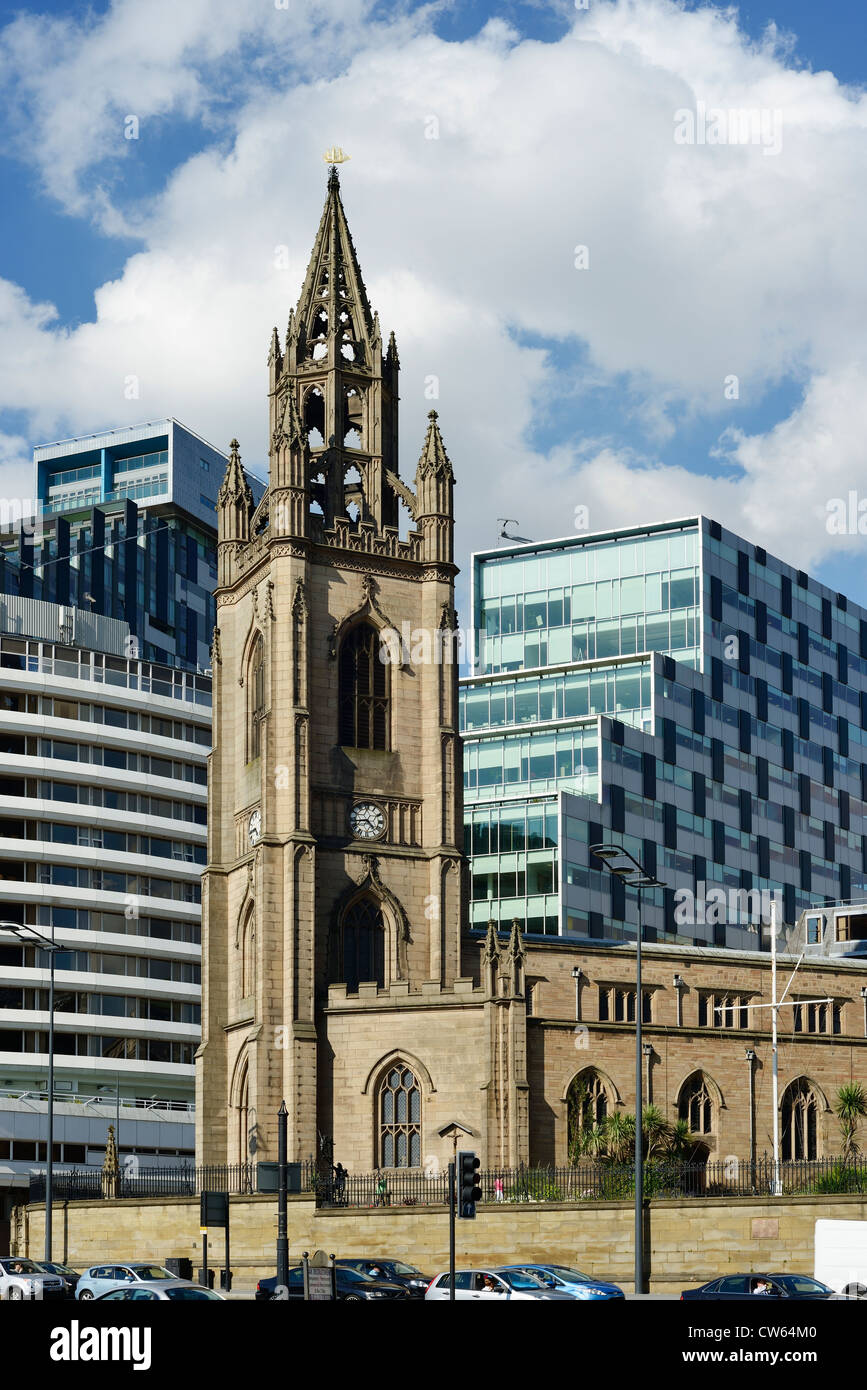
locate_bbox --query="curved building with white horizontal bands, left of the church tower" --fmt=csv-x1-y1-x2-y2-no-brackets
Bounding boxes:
0,596,211,1234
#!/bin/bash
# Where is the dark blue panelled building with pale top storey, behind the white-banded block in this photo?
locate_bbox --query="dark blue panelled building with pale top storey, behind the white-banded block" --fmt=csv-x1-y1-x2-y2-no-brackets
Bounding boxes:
0,420,261,670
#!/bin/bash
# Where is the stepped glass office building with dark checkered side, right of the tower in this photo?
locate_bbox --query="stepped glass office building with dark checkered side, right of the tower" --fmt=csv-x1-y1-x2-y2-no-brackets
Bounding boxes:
461,517,867,948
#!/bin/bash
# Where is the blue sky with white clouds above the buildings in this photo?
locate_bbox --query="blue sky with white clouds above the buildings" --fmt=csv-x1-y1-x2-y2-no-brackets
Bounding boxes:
0,0,867,600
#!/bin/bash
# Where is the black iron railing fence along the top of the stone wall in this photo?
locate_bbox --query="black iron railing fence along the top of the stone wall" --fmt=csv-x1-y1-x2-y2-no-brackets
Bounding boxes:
29,1154,867,1207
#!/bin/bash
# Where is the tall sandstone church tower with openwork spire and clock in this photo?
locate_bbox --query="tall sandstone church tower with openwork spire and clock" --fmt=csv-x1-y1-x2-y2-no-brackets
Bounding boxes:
197,167,511,1170
